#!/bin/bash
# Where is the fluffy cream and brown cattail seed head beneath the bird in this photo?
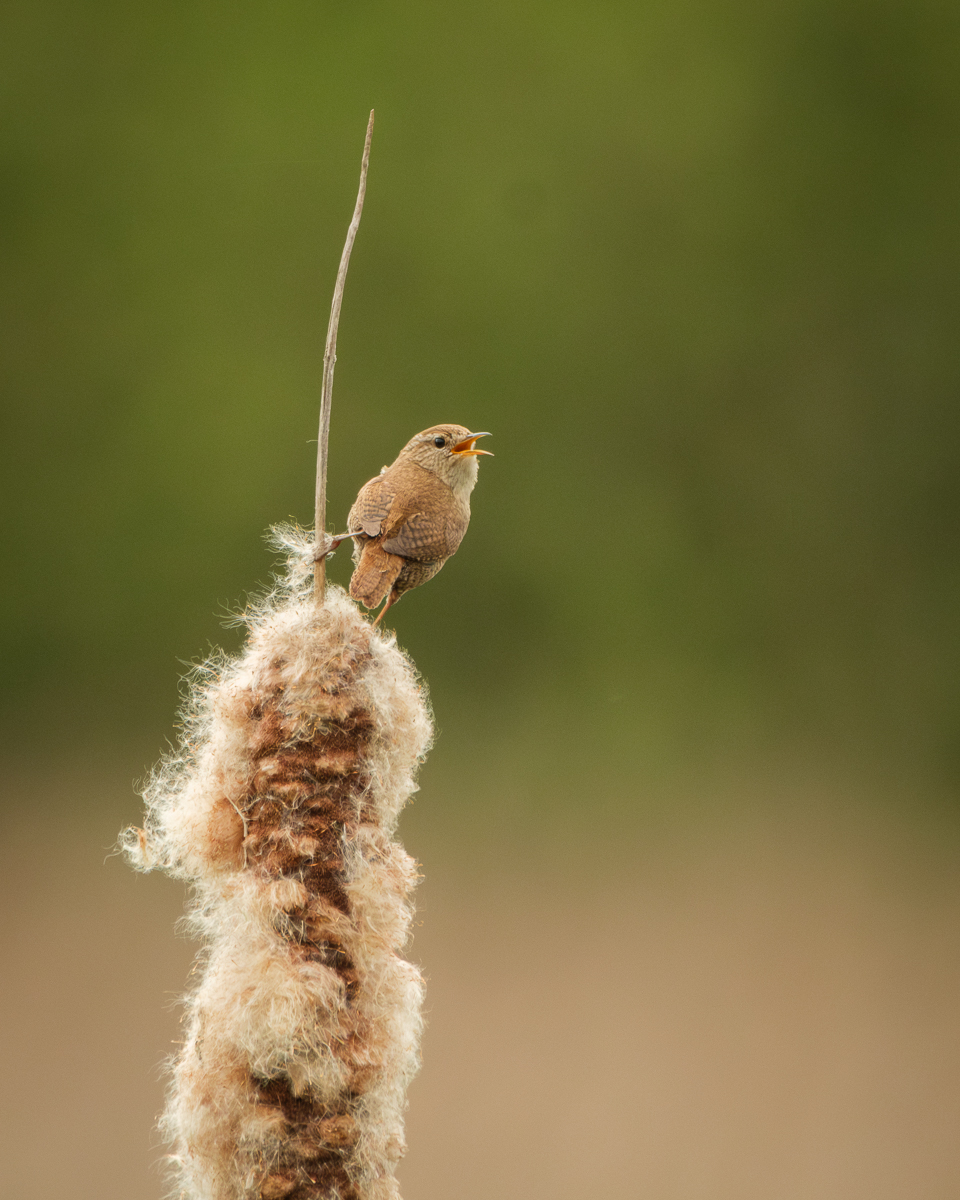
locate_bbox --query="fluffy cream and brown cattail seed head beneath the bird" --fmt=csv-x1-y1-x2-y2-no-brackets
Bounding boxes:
124,530,431,1200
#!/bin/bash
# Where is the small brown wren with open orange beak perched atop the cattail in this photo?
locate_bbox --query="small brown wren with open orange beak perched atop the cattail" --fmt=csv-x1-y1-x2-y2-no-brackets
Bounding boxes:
347,425,492,625
